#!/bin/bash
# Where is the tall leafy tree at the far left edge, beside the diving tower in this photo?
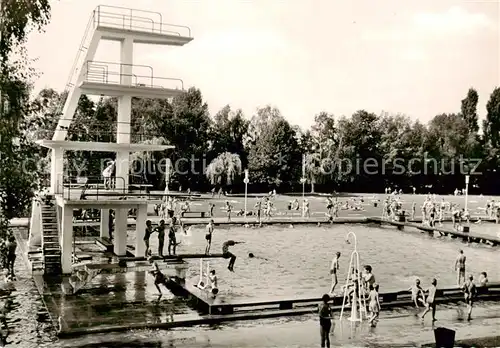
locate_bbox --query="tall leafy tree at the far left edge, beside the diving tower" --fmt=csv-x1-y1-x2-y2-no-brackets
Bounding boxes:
0,0,50,231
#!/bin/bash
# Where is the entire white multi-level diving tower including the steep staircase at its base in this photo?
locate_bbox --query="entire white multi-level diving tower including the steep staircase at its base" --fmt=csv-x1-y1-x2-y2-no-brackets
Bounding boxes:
29,5,193,276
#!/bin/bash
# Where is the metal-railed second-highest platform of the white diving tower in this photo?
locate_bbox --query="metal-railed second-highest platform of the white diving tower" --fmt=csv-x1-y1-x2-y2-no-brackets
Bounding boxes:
84,61,184,91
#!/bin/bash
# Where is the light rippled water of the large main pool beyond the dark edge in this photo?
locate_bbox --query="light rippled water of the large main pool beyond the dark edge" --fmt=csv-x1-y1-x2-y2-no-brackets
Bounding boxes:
129,225,500,300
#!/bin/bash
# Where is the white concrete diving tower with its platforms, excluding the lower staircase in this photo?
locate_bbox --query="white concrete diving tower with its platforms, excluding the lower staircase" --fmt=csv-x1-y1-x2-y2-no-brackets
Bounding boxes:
34,5,193,274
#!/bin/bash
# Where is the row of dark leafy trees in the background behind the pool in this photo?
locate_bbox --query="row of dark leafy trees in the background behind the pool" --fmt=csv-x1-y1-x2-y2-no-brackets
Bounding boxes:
28,83,500,194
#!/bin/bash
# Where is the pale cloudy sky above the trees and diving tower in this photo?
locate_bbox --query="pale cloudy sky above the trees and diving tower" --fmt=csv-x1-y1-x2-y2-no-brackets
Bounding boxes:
28,0,500,127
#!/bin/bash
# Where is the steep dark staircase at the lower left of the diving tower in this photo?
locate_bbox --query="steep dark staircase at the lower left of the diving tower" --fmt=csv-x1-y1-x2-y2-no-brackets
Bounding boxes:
42,197,62,275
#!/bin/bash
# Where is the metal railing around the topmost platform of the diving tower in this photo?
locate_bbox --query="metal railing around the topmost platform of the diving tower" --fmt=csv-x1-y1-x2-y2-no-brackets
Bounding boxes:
92,5,191,38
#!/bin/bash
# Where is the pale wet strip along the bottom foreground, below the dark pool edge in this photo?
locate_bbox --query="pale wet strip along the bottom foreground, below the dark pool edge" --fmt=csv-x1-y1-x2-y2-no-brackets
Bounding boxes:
54,303,500,348
